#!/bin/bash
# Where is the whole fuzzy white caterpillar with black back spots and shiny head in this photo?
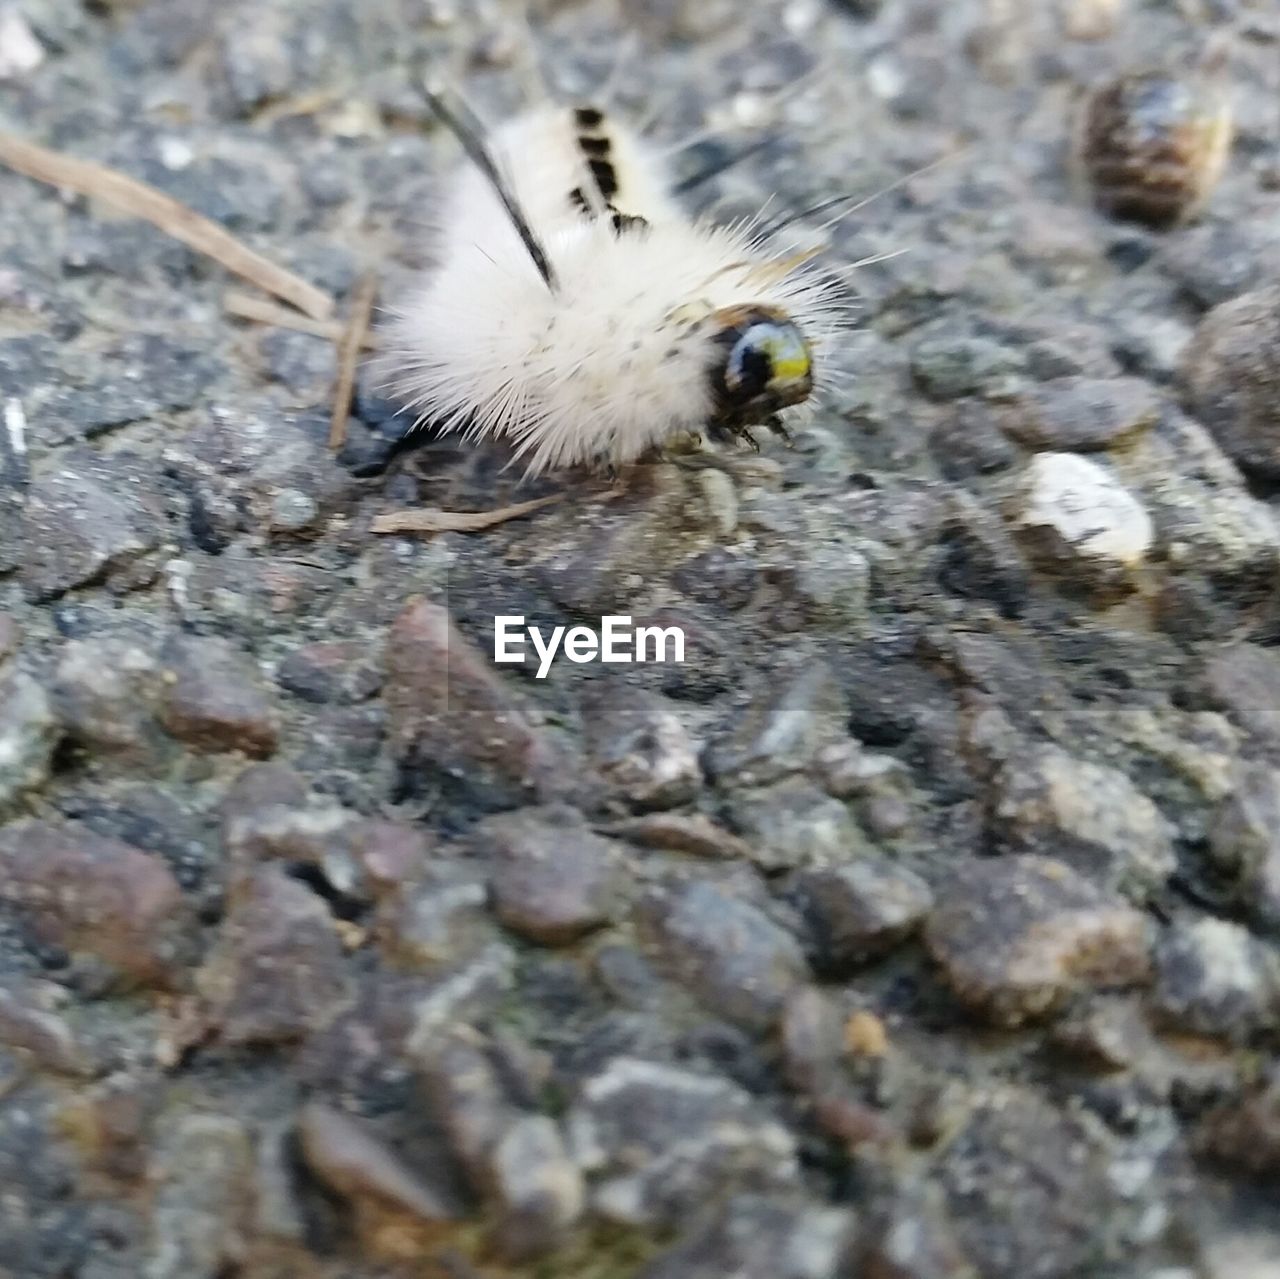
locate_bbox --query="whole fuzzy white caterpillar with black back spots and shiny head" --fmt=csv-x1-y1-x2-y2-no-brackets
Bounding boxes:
384,93,845,475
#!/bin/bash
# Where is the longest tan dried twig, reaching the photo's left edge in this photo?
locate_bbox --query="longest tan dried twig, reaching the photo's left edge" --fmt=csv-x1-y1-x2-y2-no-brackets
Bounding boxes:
0,131,333,320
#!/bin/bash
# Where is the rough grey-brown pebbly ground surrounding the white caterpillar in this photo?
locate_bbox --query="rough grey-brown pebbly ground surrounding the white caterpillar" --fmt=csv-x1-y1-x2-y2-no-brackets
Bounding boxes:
0,0,1280,1279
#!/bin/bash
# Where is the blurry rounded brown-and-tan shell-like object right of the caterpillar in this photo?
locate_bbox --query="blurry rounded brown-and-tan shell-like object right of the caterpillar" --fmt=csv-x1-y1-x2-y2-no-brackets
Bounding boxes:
1079,72,1234,227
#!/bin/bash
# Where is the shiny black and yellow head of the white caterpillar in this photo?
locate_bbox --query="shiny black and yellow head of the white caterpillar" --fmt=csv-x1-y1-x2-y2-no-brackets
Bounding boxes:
708,305,813,431
